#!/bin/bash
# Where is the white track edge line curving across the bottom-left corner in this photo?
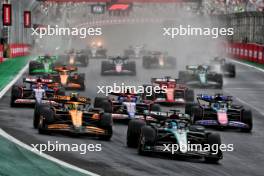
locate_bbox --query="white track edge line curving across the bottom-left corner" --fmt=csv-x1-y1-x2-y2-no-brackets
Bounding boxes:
0,129,99,176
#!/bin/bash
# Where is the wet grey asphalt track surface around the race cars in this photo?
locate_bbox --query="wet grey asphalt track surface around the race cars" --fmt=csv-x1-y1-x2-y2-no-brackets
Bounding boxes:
0,56,264,176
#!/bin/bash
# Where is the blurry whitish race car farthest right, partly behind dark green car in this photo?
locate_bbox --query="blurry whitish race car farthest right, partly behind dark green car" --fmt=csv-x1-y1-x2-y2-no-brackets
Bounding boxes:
210,57,236,78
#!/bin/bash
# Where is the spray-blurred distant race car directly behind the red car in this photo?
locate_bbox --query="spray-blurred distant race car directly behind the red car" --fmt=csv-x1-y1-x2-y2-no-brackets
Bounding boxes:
142,52,176,69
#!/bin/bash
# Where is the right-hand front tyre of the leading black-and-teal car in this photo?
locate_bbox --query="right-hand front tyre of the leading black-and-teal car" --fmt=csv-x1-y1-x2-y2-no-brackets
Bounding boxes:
204,133,223,163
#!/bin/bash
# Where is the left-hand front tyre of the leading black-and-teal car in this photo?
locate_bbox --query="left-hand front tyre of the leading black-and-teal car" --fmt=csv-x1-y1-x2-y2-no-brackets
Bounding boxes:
138,126,156,156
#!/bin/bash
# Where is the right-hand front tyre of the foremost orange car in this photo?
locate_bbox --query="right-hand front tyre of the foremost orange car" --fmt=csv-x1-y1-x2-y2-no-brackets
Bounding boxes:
99,113,113,141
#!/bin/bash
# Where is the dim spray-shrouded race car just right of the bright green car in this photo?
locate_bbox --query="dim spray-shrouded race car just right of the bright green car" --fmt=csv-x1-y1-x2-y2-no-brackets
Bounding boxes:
56,50,89,67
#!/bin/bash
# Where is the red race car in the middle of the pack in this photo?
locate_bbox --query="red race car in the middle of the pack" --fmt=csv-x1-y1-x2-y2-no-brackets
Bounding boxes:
142,76,194,105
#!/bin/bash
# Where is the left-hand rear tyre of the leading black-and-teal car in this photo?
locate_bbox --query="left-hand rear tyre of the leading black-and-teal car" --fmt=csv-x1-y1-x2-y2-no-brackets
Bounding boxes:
127,119,146,148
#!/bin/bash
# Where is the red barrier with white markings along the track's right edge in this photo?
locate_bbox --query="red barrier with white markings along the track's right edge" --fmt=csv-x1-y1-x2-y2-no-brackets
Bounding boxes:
225,43,264,64
